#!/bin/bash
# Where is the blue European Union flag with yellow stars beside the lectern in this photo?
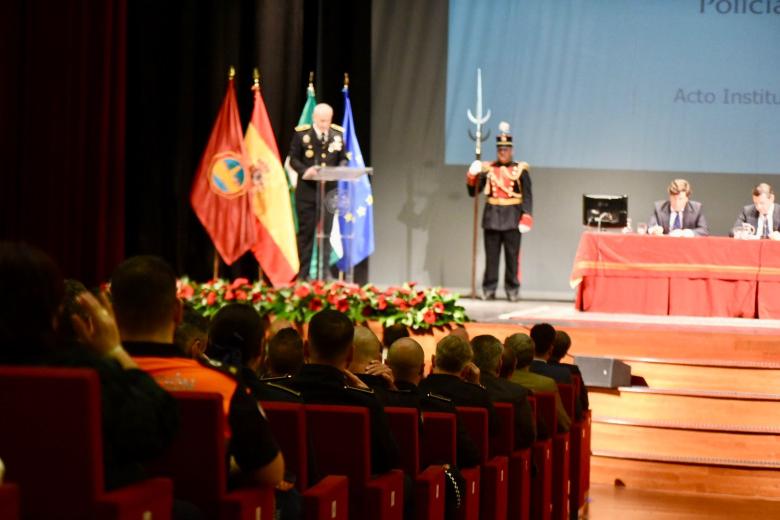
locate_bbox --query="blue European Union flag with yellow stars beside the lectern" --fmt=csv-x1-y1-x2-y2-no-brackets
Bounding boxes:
338,85,374,272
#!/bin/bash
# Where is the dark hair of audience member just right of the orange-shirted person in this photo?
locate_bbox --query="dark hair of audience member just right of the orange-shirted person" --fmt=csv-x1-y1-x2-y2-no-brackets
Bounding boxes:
206,303,265,366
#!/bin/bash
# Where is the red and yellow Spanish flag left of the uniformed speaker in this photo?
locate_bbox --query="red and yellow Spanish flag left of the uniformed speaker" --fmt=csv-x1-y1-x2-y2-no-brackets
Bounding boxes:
244,74,299,286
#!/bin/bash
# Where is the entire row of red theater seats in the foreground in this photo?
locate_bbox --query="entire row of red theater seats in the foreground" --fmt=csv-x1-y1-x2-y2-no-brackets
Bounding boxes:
0,367,590,520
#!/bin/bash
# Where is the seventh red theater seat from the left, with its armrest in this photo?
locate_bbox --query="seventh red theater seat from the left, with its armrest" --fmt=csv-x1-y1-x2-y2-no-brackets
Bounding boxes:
457,406,509,520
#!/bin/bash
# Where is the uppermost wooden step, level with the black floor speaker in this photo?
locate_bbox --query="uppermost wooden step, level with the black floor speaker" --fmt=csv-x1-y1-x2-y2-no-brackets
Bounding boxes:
624,359,780,393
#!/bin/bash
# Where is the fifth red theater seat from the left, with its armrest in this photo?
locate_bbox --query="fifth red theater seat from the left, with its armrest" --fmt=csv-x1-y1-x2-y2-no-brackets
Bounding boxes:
385,407,445,520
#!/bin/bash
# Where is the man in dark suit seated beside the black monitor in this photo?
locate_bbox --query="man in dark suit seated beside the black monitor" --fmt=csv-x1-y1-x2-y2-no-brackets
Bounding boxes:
647,179,709,237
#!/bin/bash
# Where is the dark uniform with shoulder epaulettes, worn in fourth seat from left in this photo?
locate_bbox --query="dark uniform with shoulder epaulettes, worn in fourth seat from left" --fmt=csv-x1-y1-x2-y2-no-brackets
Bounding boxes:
288,364,401,474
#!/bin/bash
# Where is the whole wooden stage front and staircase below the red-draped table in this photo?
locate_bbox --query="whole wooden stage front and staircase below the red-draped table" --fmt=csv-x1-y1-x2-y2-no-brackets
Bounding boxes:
454,299,780,517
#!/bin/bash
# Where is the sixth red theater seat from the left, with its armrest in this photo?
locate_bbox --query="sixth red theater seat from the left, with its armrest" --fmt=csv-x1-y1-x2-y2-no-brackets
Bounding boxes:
420,412,480,520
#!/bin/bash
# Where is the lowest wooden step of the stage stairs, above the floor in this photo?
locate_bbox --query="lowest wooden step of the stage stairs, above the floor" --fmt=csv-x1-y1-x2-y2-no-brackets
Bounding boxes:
591,455,780,500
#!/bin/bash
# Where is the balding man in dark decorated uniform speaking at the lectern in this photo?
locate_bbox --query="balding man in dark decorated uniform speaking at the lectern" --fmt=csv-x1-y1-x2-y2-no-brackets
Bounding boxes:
290,103,349,280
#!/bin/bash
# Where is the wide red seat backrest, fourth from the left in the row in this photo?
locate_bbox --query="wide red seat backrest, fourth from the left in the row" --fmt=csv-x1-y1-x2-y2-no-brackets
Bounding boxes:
304,404,371,490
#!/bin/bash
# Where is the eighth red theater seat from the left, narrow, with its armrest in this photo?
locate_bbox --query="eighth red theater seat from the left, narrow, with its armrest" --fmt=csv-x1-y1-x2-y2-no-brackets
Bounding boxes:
490,403,531,520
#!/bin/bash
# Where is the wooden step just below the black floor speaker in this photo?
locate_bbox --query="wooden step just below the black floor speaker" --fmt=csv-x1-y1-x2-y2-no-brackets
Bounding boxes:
589,391,780,435
